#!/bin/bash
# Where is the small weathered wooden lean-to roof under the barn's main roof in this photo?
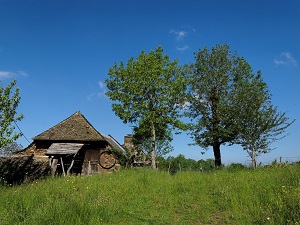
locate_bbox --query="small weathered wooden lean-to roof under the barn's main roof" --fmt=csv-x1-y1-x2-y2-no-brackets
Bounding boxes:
46,143,84,155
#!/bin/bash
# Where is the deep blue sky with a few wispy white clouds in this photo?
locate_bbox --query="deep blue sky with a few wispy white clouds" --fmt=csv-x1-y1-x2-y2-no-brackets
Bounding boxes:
0,0,300,163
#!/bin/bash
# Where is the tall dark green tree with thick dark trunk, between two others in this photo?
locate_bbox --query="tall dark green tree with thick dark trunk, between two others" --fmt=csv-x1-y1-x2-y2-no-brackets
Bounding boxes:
186,44,268,167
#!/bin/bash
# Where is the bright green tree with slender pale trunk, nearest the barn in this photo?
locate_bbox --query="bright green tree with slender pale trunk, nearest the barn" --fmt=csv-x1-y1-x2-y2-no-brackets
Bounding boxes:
105,46,185,168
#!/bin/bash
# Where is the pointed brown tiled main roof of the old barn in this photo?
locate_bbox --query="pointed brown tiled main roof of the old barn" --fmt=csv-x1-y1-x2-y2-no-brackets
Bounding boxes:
33,112,105,141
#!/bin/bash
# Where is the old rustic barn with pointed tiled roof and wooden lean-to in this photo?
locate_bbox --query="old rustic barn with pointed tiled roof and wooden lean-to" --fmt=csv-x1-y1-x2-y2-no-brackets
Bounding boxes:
15,112,125,175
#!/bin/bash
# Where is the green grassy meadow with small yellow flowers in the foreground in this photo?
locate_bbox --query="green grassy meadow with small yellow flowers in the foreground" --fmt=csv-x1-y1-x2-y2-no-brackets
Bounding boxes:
0,165,300,225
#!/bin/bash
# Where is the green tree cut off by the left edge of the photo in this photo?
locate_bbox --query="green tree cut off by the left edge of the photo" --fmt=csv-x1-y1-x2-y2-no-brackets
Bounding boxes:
0,80,23,148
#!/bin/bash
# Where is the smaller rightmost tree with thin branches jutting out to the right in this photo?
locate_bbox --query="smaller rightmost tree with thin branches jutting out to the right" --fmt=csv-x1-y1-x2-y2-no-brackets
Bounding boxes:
233,73,295,168
